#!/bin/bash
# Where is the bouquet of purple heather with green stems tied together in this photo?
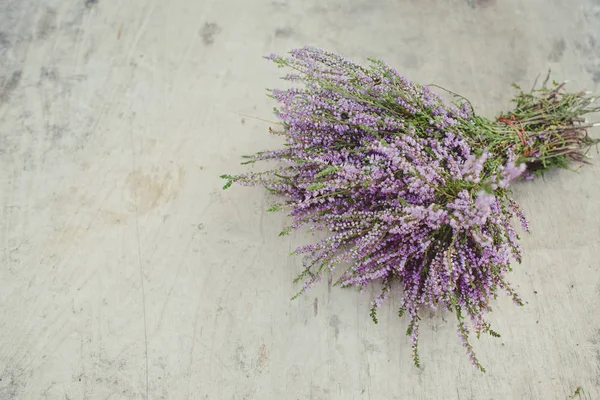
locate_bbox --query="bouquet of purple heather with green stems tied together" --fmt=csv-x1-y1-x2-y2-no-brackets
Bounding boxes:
222,47,598,370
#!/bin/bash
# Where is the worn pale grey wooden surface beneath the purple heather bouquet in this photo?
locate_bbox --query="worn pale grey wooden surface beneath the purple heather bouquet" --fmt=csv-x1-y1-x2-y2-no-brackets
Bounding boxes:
0,0,600,400
